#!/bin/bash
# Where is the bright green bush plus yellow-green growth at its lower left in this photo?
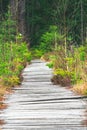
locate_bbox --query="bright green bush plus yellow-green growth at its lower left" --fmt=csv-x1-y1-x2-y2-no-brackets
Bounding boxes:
32,25,63,57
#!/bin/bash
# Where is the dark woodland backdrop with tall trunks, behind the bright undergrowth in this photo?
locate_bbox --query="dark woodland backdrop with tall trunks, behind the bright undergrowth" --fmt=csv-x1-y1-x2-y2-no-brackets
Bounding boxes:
0,0,87,45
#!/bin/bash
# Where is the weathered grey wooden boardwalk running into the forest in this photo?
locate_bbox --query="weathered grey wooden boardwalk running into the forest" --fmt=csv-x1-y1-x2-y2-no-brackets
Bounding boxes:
0,60,87,130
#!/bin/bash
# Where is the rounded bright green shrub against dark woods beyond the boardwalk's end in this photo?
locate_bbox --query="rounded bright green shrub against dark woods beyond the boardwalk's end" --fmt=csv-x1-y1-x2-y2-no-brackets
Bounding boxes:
39,25,62,53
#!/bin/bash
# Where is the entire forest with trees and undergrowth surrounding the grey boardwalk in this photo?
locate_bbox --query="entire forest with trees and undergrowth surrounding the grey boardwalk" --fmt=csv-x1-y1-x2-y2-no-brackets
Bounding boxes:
0,0,87,96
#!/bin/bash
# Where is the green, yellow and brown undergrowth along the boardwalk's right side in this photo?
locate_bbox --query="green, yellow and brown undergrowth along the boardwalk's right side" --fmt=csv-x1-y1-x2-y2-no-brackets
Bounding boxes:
32,26,87,94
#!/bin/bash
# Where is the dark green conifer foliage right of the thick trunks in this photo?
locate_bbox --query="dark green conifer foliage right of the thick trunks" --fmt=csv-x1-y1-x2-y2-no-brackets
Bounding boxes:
26,0,87,46
